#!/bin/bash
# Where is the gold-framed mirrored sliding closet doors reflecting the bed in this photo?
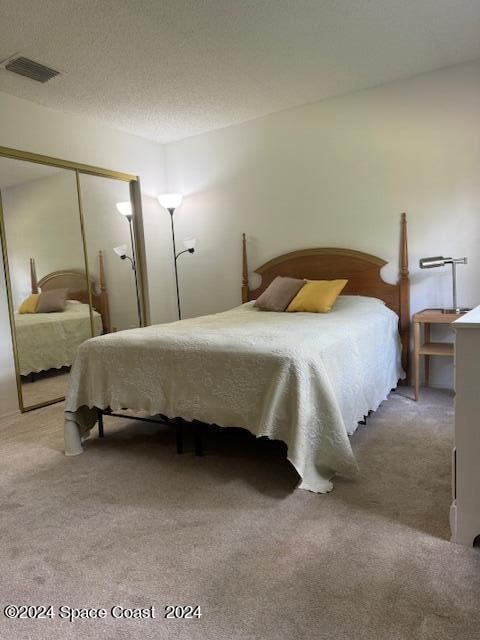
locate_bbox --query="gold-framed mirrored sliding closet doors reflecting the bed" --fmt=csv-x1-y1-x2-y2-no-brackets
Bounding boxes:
0,148,148,411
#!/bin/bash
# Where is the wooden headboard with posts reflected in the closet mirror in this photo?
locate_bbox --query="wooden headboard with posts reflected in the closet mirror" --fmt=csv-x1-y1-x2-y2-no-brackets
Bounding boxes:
30,251,111,333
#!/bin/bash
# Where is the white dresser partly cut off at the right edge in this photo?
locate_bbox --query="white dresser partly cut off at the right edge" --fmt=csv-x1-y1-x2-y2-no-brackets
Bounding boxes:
450,306,480,546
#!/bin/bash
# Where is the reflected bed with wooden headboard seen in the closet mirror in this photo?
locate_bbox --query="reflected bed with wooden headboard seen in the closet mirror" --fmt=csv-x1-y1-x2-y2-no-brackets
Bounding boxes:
15,253,110,376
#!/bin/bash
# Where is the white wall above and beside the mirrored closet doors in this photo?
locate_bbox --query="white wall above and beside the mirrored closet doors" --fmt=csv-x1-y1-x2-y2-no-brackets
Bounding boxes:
0,93,175,416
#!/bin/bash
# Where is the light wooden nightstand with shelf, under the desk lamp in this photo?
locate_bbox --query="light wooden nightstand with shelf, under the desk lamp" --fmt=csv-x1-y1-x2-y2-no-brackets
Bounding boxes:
413,309,463,400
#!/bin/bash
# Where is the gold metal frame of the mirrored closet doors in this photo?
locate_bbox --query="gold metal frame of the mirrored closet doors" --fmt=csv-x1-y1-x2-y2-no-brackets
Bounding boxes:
0,146,150,413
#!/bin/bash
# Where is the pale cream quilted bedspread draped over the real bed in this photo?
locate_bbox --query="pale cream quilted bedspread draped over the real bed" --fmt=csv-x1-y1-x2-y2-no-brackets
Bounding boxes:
65,296,403,493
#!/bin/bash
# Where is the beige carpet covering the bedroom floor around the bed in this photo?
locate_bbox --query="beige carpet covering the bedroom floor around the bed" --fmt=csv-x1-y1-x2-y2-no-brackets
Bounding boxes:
0,390,480,640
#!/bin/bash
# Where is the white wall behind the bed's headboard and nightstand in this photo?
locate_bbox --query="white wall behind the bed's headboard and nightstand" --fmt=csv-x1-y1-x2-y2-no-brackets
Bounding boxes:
166,63,480,386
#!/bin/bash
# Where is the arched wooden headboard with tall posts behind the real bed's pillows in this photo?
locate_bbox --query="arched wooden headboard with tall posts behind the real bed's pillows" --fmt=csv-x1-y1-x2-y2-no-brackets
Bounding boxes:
242,213,410,379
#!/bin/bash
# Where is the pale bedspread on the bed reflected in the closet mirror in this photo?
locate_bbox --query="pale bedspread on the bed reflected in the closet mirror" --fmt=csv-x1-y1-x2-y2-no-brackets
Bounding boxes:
15,301,102,376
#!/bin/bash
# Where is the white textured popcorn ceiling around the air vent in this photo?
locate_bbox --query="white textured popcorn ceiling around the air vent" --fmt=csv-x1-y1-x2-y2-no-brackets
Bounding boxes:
0,0,480,142
